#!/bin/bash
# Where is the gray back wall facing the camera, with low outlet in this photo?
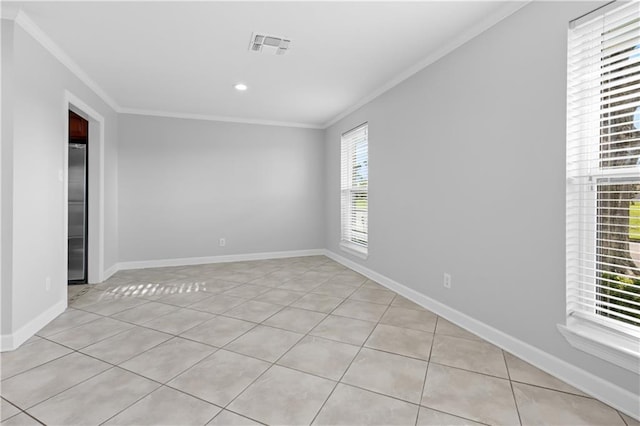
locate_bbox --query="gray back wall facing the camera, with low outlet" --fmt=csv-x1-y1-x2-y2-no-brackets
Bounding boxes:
119,115,324,262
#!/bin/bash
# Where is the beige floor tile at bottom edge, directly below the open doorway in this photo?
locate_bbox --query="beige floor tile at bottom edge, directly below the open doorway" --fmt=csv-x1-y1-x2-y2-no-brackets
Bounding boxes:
28,367,159,425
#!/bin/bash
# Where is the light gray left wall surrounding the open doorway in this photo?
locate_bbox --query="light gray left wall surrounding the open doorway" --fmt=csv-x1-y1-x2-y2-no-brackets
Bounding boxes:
2,21,118,344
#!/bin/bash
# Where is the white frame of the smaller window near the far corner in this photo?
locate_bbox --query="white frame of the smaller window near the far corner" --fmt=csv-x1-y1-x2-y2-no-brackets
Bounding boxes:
339,122,369,259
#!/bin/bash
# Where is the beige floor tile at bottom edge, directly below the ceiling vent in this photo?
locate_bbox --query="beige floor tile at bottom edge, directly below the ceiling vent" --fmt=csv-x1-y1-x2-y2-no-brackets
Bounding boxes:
229,366,335,425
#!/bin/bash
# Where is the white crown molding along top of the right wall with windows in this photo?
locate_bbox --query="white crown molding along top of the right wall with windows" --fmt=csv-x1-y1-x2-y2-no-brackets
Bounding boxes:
322,0,533,129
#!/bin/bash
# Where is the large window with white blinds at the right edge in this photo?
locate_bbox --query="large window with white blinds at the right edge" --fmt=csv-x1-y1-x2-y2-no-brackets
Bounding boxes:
561,2,640,371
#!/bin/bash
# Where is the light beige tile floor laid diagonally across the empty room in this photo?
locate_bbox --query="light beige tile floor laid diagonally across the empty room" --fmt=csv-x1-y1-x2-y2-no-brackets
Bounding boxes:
0,256,640,426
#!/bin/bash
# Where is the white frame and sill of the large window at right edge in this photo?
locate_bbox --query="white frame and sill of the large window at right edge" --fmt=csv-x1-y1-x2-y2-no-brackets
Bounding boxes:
558,3,640,372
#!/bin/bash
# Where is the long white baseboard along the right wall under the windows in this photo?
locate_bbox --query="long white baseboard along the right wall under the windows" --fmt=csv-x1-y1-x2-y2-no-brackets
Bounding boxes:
324,250,640,419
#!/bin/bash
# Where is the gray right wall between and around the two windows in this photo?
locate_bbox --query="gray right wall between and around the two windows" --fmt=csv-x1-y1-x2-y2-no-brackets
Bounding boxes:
325,2,640,393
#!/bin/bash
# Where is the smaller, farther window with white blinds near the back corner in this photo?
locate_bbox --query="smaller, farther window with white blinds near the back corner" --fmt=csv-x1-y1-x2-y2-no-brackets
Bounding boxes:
340,123,369,257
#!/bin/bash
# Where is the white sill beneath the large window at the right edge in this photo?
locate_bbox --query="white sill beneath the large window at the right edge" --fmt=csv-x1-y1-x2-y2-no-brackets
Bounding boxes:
558,316,640,374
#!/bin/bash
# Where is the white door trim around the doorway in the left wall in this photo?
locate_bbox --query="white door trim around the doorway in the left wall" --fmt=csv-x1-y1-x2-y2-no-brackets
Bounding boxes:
63,90,105,282
